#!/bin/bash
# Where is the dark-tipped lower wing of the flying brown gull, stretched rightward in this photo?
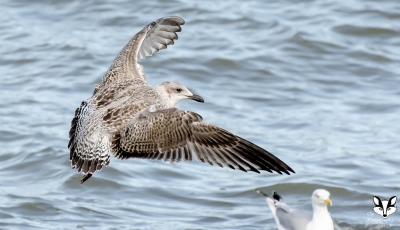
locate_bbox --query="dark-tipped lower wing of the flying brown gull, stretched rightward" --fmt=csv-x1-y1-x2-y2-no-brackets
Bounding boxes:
111,108,294,174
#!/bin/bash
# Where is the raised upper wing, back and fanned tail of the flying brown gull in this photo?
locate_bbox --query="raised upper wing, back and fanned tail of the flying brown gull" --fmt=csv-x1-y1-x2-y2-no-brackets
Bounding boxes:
68,17,184,183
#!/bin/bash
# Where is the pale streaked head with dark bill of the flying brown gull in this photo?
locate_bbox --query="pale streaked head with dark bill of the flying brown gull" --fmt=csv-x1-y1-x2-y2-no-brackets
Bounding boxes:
156,81,204,108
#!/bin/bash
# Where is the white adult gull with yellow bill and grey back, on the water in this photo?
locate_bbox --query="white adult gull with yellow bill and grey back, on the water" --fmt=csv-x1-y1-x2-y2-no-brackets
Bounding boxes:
256,189,340,230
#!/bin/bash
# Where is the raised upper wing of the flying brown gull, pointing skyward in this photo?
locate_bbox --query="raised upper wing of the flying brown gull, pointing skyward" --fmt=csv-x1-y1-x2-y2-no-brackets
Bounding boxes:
100,17,185,88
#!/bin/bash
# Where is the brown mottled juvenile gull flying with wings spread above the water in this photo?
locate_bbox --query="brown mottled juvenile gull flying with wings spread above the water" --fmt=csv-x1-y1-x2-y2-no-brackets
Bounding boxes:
68,17,294,183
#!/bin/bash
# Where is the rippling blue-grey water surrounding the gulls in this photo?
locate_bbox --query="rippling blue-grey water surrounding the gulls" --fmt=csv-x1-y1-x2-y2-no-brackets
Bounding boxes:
0,0,400,229
